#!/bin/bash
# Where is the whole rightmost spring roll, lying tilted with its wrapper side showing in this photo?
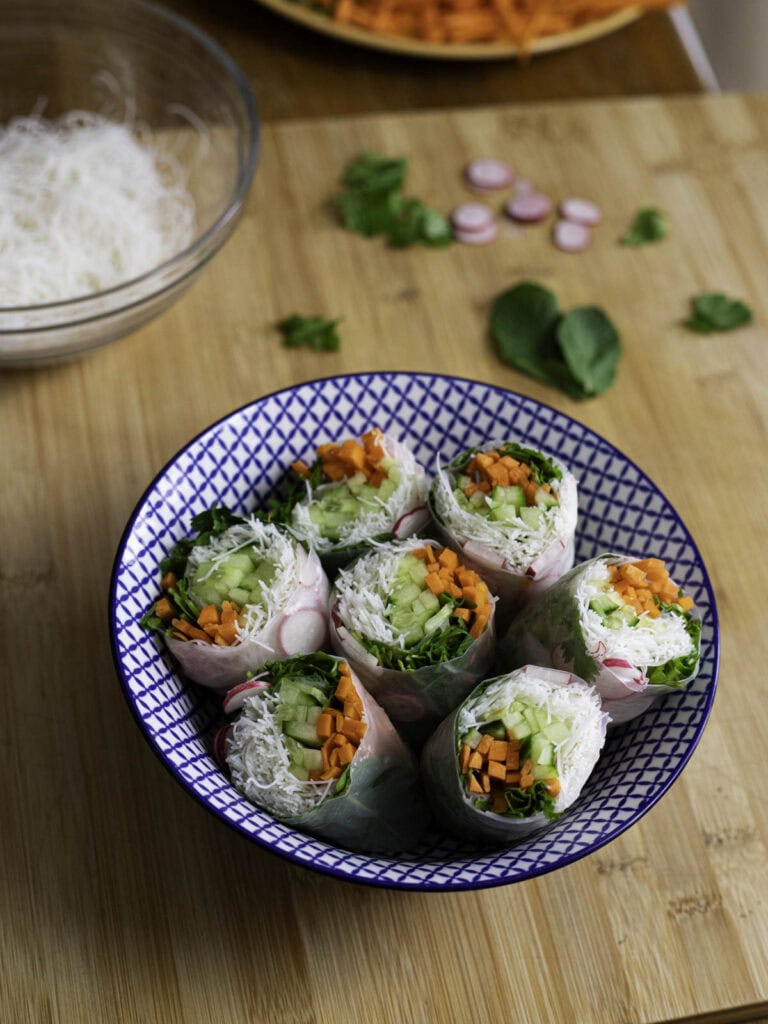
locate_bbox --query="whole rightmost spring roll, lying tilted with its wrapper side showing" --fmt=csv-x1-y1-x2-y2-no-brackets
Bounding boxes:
500,554,701,724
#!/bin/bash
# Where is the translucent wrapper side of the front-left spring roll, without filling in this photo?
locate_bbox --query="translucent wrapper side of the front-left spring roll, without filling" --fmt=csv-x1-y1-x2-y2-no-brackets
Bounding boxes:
229,666,431,854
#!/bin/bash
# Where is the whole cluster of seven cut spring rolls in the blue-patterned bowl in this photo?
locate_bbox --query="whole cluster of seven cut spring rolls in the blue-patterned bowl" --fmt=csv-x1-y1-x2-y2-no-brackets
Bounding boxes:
141,428,700,853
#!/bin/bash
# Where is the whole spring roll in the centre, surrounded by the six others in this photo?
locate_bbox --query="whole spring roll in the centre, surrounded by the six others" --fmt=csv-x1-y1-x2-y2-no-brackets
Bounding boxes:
331,538,495,745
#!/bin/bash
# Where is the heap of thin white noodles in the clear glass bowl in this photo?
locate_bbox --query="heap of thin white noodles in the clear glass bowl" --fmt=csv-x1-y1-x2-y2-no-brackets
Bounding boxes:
0,111,195,307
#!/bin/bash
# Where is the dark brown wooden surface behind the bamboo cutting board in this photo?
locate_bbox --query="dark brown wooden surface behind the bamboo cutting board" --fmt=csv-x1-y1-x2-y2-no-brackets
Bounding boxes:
169,0,701,122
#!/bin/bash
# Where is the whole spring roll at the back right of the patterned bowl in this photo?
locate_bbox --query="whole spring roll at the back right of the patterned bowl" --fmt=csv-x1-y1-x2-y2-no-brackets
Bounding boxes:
429,441,578,618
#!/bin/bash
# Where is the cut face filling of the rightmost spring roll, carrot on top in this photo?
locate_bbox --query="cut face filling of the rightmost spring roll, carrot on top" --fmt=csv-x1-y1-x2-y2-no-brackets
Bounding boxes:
577,558,700,683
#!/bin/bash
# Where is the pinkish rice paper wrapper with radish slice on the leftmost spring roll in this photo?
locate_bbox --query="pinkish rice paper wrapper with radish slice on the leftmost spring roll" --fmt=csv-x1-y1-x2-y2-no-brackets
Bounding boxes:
166,540,330,691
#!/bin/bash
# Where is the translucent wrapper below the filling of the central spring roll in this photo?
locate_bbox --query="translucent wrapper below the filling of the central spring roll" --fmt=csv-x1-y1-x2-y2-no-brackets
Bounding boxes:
331,608,496,749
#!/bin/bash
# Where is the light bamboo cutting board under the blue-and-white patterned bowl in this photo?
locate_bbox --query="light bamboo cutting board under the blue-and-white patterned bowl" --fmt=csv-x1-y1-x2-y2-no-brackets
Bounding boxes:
0,90,768,1024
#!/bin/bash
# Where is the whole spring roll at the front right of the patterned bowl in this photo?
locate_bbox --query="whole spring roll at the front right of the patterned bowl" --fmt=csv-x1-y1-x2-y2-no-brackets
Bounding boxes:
422,666,607,843
